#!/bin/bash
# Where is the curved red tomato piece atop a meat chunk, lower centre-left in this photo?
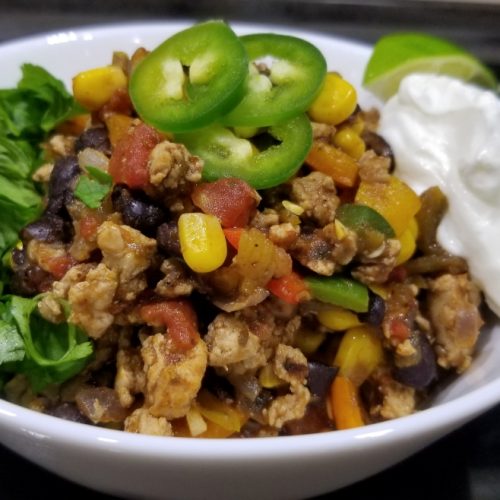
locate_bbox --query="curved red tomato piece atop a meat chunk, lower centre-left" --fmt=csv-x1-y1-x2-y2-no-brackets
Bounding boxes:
140,300,200,351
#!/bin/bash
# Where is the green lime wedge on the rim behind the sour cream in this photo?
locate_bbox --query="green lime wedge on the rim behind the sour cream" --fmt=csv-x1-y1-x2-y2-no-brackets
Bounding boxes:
363,33,497,100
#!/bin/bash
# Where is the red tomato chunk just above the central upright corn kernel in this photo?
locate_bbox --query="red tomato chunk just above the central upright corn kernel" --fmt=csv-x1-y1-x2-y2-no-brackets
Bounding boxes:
191,177,258,227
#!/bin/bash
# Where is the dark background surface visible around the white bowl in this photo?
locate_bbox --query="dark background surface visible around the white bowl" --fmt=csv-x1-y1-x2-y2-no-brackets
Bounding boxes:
0,0,500,500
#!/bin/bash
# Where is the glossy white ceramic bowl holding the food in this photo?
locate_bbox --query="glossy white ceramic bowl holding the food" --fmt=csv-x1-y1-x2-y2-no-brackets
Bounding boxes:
0,23,500,500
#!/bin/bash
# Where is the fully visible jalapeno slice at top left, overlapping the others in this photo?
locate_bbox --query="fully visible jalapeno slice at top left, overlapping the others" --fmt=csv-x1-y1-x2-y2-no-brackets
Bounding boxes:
130,21,248,132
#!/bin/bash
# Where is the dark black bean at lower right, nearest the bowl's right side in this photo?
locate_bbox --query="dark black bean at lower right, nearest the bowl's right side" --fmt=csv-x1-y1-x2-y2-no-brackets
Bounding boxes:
394,332,437,389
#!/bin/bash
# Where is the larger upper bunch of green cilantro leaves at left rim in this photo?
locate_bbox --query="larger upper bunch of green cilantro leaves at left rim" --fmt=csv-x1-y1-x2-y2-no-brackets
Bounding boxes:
0,64,82,260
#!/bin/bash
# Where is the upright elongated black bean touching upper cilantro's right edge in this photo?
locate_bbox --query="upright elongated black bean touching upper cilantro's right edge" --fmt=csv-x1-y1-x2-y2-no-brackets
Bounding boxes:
46,156,81,214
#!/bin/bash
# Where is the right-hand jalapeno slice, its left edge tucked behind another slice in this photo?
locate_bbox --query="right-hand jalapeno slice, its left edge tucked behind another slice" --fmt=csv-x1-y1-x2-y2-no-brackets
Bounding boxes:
222,33,326,127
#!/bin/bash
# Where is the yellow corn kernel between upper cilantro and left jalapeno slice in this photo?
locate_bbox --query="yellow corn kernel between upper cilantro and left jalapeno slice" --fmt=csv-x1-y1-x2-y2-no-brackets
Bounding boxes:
73,66,127,111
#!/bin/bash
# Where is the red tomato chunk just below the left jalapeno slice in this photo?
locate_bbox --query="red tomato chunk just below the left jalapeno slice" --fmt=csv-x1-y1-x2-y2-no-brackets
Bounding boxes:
109,123,161,188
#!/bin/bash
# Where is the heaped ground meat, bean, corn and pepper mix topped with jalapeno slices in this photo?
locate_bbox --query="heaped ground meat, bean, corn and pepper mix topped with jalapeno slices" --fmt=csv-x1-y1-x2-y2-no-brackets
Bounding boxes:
2,23,494,437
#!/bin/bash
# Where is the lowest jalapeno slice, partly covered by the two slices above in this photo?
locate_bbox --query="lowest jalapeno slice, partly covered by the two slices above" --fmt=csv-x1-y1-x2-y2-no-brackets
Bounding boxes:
175,114,312,189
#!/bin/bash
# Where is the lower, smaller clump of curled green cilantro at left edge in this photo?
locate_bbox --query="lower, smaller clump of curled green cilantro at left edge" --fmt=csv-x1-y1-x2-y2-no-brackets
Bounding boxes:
0,296,93,391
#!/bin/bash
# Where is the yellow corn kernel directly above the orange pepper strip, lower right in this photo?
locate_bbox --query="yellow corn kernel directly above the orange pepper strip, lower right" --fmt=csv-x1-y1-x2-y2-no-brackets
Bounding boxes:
334,325,383,386
